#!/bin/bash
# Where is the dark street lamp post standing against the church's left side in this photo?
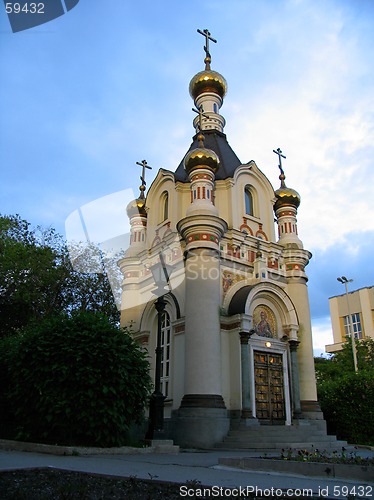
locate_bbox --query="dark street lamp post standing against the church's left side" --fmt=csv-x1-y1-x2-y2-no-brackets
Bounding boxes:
146,252,172,439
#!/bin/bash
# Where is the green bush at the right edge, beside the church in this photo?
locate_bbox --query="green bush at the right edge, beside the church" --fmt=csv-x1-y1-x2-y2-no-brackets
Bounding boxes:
318,370,374,445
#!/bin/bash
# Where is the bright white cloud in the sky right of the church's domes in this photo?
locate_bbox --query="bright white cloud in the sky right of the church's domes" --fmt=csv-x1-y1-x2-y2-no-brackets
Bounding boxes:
227,2,374,250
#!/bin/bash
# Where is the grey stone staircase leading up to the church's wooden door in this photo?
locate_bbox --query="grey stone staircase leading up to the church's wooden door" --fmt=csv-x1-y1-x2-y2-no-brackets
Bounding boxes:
215,420,353,452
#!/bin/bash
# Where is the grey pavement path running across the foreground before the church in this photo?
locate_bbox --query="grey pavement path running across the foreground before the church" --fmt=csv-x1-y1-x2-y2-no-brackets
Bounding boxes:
0,450,374,499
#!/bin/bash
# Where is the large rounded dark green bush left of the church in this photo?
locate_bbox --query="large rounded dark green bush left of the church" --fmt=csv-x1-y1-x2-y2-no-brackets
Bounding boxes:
3,313,150,447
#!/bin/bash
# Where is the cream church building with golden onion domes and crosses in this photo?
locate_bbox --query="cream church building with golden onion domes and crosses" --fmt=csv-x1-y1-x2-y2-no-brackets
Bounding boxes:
120,30,323,448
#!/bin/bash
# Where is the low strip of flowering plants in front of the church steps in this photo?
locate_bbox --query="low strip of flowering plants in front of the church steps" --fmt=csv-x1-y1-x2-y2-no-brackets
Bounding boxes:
280,447,374,466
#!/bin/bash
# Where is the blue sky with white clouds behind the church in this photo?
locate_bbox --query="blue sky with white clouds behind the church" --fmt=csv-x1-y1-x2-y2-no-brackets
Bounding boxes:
0,0,374,355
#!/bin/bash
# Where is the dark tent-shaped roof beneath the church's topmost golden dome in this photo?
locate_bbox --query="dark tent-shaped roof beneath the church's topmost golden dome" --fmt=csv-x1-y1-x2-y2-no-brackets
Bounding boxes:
175,130,242,182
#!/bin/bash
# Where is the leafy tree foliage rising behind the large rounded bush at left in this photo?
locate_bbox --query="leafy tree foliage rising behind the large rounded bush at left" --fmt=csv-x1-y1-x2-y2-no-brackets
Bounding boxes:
0,215,118,337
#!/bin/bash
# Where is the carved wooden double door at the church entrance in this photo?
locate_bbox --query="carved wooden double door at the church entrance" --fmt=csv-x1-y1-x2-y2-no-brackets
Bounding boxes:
254,351,285,424
